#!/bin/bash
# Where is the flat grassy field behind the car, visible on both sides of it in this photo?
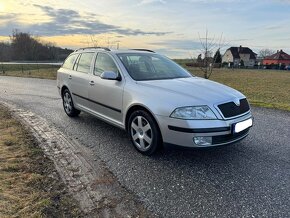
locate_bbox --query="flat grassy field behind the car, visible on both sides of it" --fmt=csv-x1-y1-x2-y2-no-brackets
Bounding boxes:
0,60,290,111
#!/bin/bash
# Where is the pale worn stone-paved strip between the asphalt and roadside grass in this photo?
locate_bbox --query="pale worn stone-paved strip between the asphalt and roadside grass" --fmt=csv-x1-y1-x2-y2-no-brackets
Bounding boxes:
4,103,154,217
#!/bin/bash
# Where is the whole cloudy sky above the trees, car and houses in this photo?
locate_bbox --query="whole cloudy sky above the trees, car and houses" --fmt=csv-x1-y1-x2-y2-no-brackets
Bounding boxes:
0,0,290,58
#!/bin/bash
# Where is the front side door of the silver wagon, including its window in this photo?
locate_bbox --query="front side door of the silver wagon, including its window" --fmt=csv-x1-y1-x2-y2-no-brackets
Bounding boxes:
89,52,125,125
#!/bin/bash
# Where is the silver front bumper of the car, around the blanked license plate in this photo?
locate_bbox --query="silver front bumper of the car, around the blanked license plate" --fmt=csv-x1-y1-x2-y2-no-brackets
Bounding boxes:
156,112,252,147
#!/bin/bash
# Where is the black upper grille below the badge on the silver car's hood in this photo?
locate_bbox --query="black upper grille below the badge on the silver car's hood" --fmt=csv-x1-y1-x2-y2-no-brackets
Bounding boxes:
218,98,250,118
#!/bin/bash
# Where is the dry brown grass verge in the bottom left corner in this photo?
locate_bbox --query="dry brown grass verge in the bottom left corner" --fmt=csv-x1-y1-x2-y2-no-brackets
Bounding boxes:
0,106,81,217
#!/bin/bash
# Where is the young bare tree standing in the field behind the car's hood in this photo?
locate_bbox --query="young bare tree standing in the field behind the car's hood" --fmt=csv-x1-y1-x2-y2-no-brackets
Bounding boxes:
193,30,226,79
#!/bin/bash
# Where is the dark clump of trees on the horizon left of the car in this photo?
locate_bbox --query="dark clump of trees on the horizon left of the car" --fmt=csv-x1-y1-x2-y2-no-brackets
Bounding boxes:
0,30,73,62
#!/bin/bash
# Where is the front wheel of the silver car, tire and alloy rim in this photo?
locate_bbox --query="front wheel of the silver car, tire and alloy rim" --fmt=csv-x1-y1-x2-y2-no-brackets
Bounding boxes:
128,110,162,156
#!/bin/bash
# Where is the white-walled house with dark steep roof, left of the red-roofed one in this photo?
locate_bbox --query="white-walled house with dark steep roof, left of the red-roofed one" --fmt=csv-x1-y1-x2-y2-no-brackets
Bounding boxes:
222,46,257,67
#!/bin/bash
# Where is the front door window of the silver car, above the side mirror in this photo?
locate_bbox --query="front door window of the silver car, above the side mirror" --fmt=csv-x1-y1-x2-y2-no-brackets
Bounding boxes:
94,53,119,76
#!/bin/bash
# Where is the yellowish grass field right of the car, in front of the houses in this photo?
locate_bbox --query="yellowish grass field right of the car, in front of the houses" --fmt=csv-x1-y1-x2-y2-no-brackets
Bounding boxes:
187,67,290,111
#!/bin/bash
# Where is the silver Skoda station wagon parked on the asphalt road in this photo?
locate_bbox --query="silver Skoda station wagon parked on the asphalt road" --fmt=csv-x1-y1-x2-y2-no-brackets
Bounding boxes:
57,47,253,155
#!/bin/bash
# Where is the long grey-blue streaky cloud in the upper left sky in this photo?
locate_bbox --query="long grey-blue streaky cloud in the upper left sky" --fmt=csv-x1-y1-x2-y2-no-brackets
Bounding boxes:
0,4,169,36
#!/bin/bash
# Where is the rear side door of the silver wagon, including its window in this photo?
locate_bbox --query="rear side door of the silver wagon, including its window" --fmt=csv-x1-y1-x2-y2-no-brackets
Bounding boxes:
69,52,95,109
